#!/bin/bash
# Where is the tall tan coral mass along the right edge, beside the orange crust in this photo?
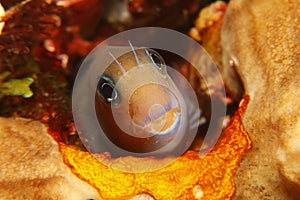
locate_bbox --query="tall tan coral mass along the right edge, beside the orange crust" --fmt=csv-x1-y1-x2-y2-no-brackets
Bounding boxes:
222,0,300,199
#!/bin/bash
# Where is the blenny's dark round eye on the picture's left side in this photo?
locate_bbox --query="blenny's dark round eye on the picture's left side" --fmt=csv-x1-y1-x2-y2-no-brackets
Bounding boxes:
97,76,119,104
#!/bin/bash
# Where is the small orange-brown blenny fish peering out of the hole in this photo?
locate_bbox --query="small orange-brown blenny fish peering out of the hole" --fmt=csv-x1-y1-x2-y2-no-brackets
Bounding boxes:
95,43,200,156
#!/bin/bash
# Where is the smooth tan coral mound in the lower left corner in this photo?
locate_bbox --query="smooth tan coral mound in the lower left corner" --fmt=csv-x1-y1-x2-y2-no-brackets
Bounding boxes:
0,118,100,200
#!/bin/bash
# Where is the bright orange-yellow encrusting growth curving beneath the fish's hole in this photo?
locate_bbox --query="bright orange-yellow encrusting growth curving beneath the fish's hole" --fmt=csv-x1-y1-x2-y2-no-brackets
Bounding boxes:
60,97,251,200
